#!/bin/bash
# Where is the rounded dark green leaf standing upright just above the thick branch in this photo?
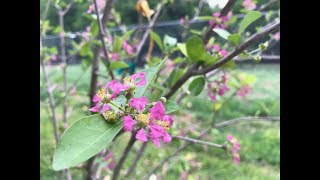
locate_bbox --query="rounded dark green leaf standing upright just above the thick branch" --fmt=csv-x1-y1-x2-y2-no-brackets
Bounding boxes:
186,36,206,62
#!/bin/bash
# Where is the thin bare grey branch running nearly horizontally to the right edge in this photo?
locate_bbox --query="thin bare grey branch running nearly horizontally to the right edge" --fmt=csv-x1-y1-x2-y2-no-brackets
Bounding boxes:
215,117,280,128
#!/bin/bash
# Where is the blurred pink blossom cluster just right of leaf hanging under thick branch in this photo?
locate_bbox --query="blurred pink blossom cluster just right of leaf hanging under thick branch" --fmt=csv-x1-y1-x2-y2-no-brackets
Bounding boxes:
207,73,230,102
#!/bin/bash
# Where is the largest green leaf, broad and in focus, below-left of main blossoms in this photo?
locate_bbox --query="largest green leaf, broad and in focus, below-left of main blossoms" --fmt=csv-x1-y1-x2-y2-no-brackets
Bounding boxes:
52,114,123,171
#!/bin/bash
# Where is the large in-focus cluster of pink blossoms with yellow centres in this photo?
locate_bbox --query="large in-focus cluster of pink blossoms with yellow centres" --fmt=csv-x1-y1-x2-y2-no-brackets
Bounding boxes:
89,72,173,147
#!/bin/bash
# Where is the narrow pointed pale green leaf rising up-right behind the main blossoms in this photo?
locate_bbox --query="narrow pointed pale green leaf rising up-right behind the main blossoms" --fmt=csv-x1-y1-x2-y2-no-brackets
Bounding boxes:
134,58,167,98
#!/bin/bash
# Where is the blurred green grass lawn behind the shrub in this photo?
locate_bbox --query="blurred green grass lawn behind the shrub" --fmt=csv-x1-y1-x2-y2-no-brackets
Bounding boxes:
40,65,280,180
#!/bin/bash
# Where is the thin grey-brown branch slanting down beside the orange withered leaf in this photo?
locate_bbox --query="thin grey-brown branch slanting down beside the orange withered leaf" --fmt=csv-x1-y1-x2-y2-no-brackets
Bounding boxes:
134,0,163,62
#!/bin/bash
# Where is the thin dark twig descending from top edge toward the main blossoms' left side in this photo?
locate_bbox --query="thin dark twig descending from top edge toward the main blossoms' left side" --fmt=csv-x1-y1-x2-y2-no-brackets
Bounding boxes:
93,0,114,79
